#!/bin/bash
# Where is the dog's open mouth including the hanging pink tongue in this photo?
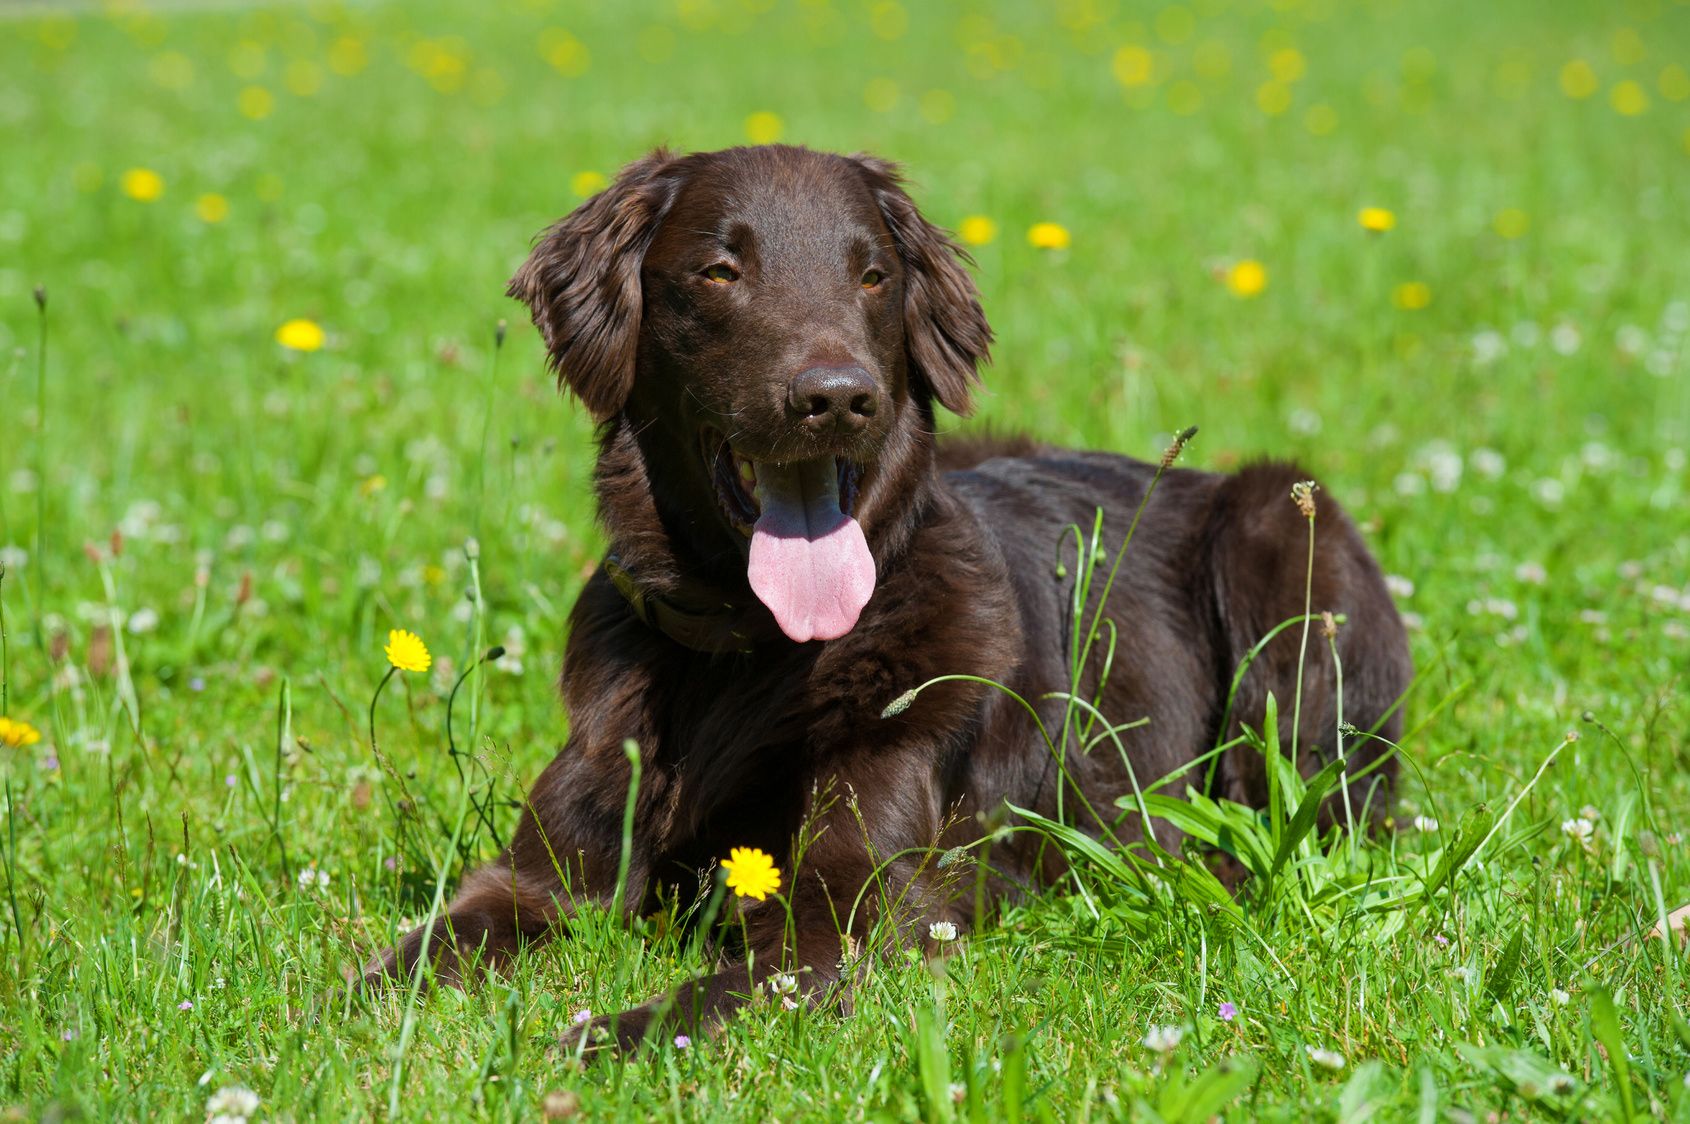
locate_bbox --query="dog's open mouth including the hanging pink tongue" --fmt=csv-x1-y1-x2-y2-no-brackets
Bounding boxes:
701,428,875,644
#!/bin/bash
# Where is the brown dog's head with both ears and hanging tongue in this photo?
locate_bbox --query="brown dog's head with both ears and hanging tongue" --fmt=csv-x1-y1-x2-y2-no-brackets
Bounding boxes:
510,145,992,641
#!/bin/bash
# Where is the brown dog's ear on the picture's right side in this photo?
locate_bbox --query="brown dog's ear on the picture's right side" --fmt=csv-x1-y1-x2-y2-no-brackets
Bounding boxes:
853,156,992,414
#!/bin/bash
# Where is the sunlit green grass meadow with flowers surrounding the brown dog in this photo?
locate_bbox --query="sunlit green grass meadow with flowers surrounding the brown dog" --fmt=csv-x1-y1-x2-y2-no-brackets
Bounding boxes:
0,0,1690,1121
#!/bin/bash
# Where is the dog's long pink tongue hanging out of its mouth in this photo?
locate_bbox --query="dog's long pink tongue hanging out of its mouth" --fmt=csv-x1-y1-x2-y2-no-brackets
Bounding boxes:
747,456,874,644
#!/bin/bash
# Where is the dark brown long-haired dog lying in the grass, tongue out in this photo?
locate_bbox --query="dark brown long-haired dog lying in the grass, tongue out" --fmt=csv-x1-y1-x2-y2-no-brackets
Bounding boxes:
367,145,1411,1046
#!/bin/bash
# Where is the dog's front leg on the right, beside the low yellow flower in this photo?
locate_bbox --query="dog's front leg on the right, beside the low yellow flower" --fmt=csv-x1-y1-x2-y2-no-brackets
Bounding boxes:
564,745,955,1050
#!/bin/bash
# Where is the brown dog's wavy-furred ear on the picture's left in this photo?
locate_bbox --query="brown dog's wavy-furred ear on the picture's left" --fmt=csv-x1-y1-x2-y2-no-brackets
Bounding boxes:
505,149,676,421
